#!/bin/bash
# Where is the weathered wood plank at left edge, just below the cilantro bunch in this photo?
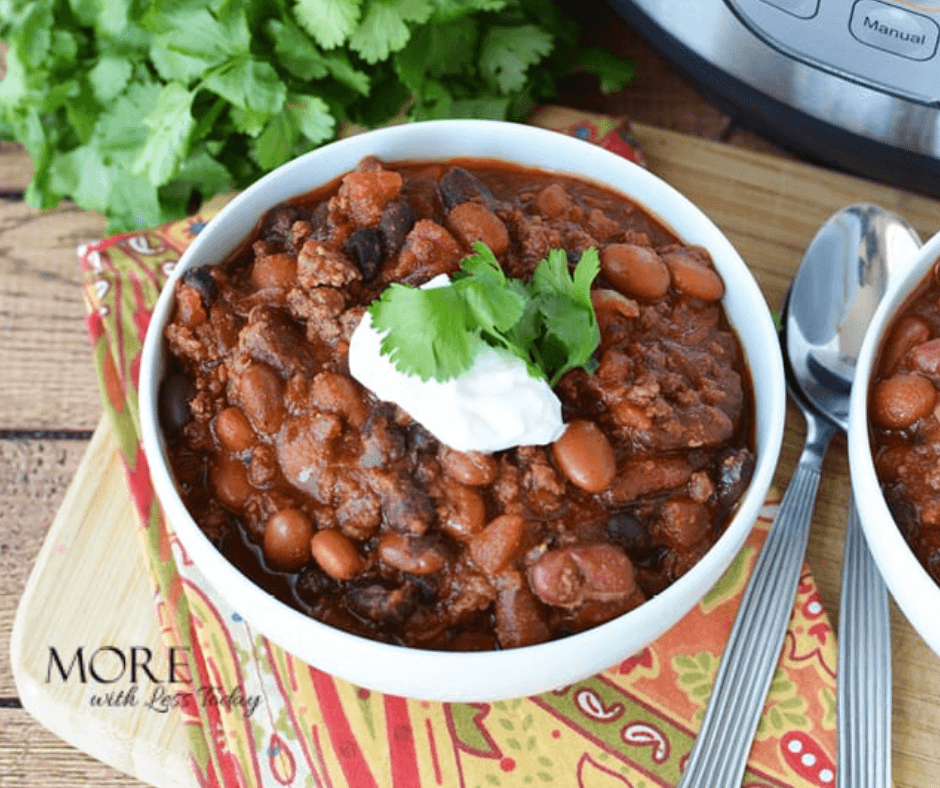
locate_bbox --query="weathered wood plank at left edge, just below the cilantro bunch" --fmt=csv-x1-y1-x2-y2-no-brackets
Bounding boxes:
0,201,105,430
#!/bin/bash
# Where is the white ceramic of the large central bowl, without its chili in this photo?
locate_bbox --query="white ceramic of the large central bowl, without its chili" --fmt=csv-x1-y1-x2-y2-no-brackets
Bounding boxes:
140,121,785,701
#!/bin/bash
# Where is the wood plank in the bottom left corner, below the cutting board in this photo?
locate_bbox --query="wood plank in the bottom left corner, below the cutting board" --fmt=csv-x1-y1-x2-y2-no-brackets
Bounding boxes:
0,709,145,788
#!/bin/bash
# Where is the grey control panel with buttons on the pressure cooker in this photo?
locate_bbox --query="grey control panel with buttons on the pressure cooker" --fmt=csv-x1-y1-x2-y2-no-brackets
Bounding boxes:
725,0,940,104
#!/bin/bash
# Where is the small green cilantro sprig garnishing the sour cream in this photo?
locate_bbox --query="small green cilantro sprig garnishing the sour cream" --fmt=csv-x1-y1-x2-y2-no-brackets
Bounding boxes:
369,242,600,386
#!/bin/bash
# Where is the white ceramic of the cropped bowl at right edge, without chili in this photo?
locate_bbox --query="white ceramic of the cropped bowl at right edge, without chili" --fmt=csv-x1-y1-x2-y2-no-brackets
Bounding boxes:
848,225,940,655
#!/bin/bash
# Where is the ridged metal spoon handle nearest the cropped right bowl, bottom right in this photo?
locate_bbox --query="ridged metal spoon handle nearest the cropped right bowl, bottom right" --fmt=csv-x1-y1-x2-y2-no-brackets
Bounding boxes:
836,498,891,788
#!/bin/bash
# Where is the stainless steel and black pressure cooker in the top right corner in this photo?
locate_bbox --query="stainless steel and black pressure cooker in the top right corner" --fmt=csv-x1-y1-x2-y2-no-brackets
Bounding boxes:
609,0,940,196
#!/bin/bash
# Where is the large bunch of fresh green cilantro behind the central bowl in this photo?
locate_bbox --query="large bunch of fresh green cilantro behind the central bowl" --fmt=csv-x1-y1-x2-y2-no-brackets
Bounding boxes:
0,0,632,231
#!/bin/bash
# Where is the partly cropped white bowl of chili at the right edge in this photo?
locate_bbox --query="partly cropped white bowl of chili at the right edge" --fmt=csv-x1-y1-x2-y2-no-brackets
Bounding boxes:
848,229,940,655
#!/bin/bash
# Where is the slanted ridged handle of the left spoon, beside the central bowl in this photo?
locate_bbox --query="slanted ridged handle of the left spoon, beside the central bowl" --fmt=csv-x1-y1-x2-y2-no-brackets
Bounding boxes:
677,413,835,788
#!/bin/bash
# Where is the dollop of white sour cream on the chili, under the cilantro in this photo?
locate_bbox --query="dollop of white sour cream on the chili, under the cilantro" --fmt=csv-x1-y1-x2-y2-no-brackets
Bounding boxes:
349,279,565,452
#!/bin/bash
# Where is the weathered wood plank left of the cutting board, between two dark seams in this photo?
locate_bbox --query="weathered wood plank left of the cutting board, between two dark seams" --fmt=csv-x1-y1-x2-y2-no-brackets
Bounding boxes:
0,440,89,696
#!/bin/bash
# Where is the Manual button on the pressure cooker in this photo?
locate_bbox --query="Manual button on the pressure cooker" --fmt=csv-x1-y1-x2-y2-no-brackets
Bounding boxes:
849,0,940,60
